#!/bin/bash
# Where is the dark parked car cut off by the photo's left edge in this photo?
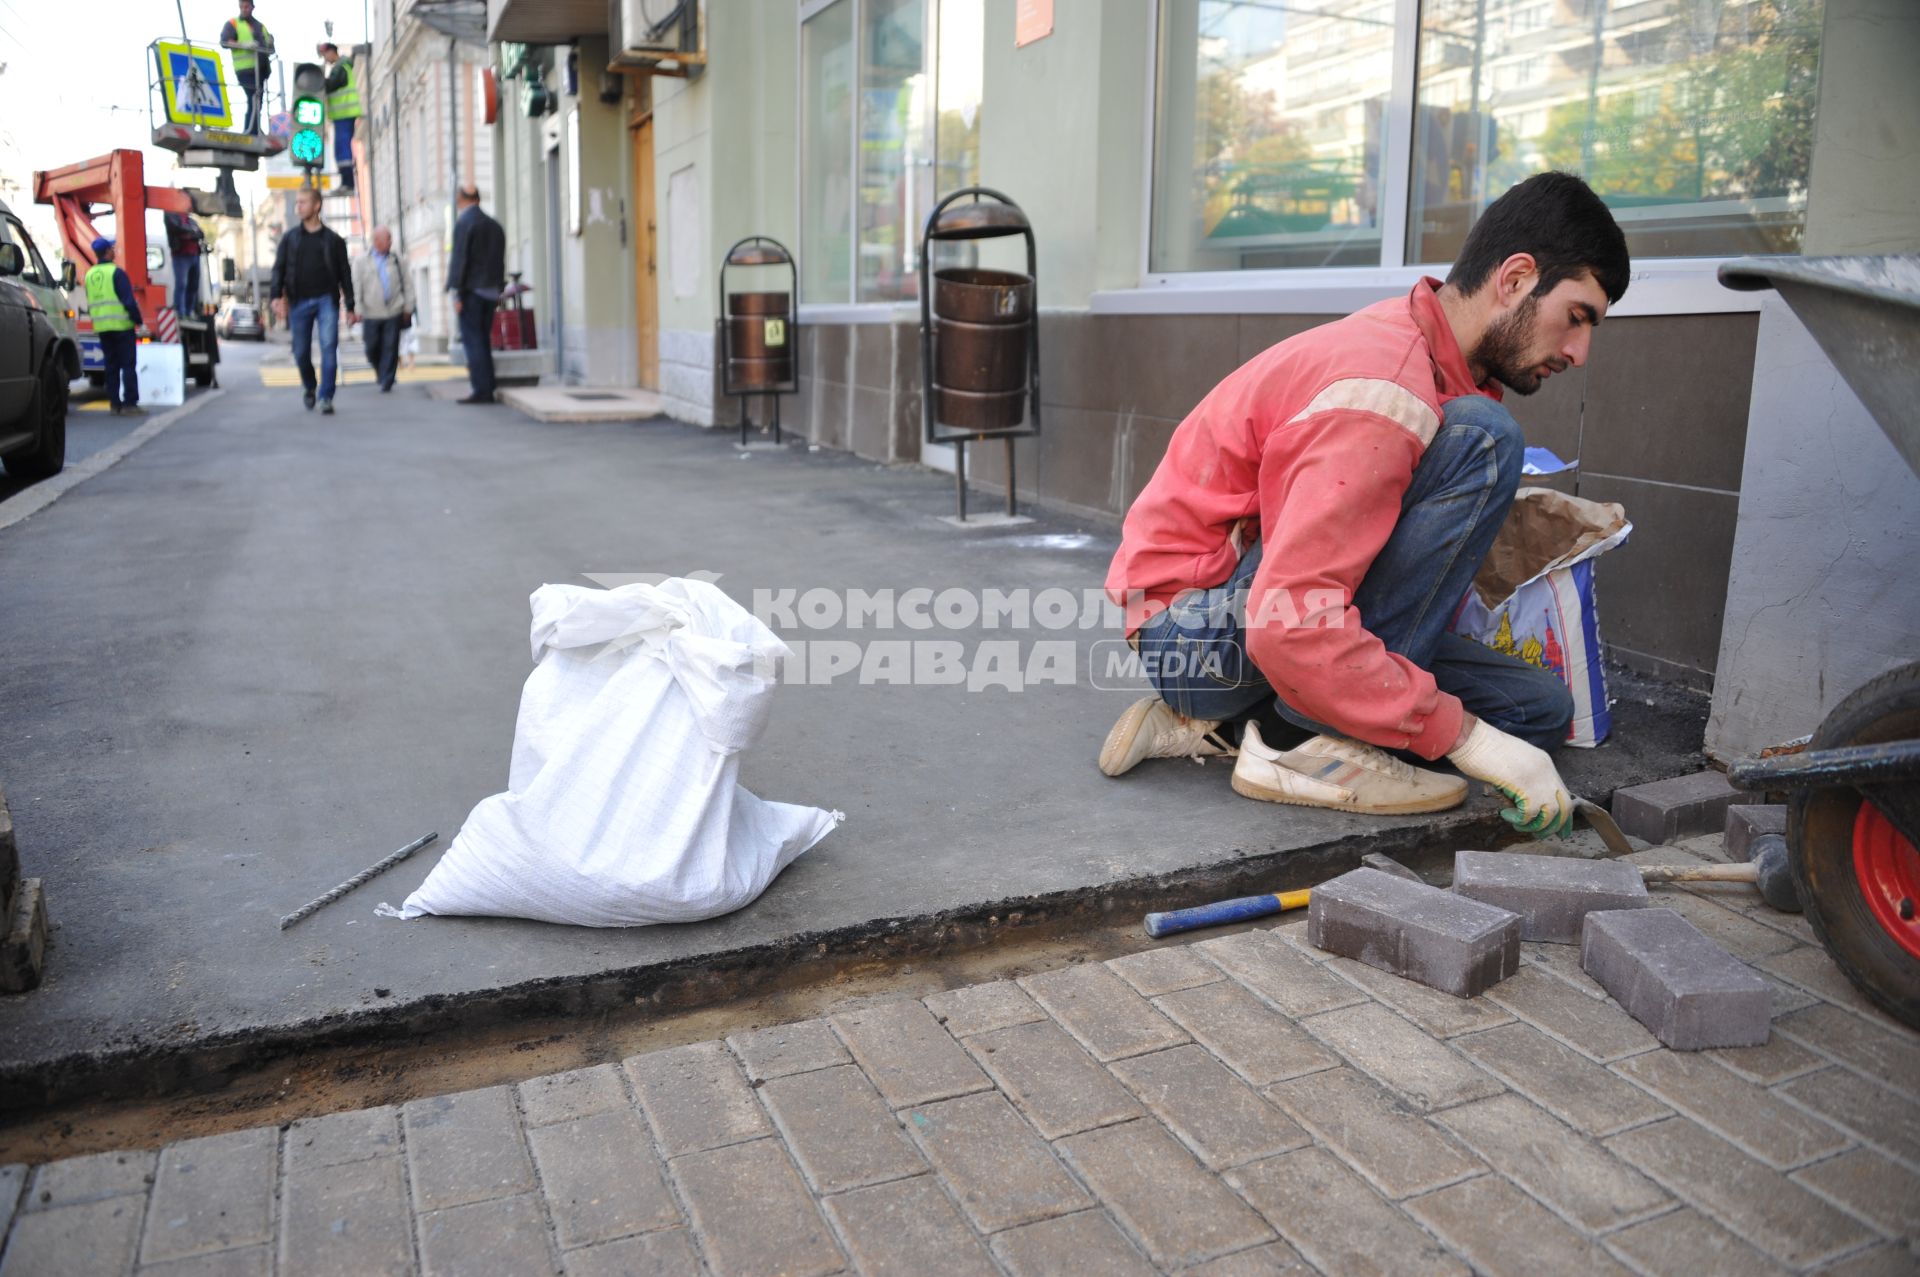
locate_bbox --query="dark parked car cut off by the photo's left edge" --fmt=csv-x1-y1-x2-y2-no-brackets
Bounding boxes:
0,204,81,478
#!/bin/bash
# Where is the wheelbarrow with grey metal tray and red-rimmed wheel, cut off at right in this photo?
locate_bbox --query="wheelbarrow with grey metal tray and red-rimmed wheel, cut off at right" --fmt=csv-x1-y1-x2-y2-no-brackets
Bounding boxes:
1720,255,1920,1027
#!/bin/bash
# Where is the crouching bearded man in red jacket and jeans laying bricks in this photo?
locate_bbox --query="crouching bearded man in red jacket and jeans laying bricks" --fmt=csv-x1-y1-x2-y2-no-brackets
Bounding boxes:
1100,173,1628,835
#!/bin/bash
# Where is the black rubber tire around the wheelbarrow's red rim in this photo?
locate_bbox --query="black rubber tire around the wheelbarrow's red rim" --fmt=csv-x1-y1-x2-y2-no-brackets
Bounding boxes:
1788,664,1920,1029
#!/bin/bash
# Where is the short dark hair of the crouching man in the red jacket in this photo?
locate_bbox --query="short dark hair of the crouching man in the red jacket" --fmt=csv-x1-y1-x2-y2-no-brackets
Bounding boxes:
1446,173,1628,301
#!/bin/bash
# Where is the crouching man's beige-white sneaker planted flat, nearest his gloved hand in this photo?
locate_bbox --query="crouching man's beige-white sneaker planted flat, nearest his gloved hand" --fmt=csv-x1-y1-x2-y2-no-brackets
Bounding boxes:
1233,722,1467,816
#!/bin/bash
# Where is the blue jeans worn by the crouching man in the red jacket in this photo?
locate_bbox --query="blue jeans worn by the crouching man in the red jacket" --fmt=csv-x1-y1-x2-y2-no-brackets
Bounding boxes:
1137,396,1572,749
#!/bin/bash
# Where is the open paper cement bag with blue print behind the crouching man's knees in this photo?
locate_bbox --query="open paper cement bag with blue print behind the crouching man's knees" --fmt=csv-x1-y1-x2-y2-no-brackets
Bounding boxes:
1450,488,1634,749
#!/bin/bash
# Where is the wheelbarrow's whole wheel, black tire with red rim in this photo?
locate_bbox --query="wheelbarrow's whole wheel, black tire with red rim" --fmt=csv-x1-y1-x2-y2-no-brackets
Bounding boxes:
1788,664,1920,1027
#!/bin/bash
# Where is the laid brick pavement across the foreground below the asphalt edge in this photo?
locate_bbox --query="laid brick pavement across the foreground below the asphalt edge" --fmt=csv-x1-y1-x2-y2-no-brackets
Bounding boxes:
0,833,1920,1277
